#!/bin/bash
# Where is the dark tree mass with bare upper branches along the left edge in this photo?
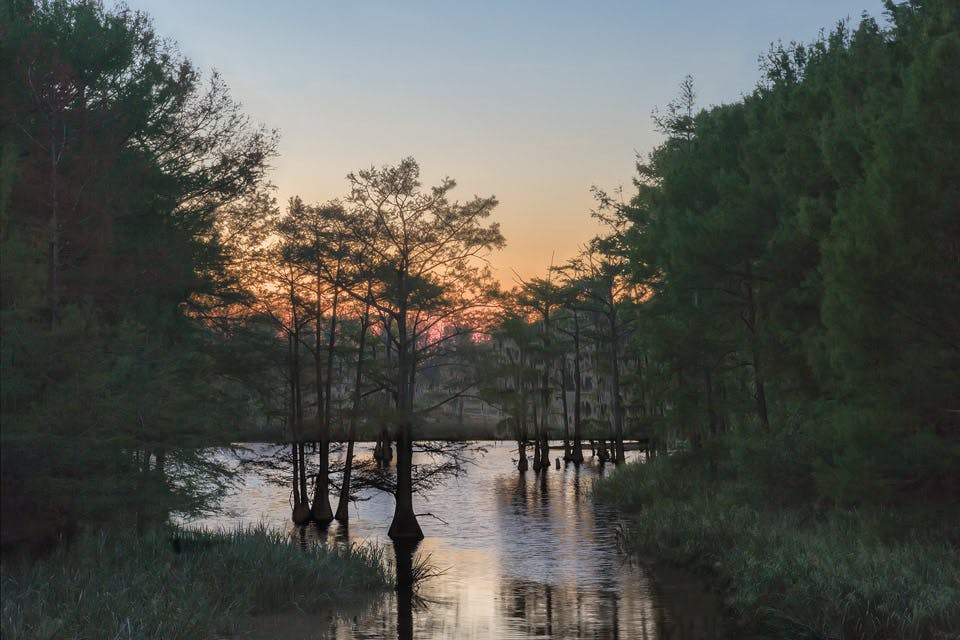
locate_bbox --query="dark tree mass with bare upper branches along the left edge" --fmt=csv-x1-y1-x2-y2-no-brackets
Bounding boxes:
0,0,275,549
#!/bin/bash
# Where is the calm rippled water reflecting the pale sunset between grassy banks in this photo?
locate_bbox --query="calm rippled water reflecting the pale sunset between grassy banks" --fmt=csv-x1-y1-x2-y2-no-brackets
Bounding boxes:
193,442,724,640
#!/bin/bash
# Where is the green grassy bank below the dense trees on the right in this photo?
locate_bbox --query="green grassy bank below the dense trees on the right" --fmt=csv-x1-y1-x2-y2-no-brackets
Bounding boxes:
595,444,960,639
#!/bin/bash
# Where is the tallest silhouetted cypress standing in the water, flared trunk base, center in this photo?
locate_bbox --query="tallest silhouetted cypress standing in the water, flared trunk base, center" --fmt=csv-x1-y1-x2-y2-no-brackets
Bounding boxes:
346,158,504,540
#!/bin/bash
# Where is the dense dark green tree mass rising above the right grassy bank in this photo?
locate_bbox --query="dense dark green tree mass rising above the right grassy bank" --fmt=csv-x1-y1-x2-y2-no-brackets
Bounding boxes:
608,0,960,504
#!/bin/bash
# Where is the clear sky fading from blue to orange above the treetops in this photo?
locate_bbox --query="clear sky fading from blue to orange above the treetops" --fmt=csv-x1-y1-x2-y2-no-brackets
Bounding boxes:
128,0,882,286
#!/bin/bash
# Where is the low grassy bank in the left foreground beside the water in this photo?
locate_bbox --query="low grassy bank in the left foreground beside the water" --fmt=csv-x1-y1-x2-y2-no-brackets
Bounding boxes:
2,528,390,640
